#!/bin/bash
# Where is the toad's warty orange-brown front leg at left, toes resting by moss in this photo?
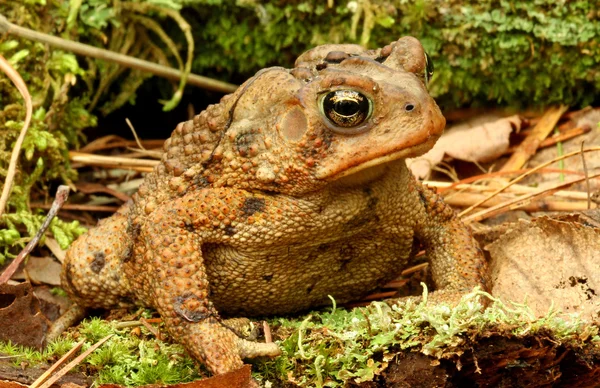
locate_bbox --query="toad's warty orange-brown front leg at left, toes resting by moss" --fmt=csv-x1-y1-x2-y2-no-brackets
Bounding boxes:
130,196,281,374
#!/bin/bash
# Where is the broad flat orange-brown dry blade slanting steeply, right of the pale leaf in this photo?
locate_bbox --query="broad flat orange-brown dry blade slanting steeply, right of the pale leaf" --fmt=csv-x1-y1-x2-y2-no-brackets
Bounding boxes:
501,105,568,171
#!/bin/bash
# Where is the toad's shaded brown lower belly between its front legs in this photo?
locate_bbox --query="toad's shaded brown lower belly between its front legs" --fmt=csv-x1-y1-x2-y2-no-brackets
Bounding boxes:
202,235,416,316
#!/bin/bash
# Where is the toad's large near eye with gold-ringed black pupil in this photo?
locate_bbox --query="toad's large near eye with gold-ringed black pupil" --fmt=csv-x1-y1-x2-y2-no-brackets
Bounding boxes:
321,90,373,128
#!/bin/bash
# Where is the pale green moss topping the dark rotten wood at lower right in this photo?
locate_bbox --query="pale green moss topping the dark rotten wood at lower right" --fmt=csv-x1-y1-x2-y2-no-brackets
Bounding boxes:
254,291,600,387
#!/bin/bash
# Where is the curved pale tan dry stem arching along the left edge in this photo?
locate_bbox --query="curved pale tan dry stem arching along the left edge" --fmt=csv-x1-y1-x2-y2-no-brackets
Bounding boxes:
0,55,33,221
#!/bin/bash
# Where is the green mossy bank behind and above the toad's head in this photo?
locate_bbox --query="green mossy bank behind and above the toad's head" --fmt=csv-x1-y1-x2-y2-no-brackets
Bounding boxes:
181,0,600,107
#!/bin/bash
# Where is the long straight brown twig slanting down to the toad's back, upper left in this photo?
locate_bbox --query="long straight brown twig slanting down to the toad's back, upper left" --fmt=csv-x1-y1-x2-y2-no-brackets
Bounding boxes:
0,15,237,93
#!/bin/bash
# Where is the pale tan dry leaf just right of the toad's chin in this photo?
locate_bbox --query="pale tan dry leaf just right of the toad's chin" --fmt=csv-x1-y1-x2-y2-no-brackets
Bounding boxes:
408,115,522,178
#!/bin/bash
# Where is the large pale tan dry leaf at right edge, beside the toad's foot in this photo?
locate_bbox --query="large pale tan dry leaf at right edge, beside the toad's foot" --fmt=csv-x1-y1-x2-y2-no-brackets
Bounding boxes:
486,211,600,319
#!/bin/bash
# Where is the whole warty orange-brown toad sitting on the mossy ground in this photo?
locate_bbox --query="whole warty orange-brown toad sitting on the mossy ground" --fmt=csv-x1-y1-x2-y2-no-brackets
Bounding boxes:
62,37,485,374
